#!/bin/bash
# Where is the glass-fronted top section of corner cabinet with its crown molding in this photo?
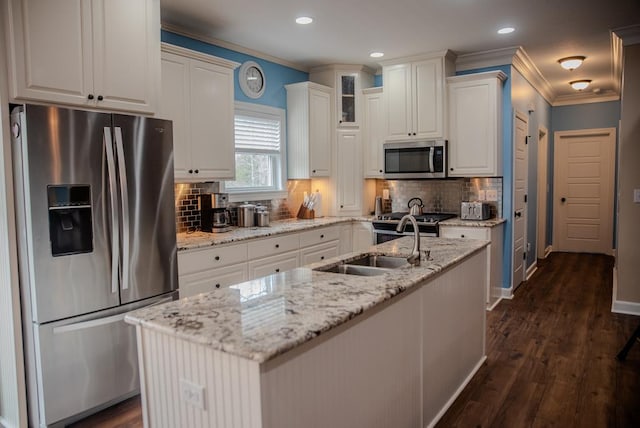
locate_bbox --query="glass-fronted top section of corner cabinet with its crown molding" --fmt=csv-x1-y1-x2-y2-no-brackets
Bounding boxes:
309,64,373,128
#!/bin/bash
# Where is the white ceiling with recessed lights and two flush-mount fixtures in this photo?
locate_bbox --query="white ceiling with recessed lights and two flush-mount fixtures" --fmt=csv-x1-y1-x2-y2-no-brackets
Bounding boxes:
161,0,640,104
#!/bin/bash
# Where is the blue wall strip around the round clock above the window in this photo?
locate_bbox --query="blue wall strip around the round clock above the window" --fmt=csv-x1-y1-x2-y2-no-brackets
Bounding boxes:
161,30,309,110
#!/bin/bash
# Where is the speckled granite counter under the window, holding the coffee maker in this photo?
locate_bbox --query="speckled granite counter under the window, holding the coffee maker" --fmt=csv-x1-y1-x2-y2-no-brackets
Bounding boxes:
177,217,371,251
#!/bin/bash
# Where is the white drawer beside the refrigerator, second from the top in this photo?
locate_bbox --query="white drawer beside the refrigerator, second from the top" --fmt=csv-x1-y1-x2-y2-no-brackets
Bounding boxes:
178,263,248,299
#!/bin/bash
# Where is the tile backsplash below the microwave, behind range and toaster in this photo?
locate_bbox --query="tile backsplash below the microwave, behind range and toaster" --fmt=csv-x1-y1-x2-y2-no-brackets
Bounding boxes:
376,177,502,217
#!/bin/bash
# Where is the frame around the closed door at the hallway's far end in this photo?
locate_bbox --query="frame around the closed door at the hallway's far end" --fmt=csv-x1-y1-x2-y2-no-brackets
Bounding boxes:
552,128,617,255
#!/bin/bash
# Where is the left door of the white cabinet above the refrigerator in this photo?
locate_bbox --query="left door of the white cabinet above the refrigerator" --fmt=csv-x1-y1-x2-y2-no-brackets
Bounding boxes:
9,0,93,105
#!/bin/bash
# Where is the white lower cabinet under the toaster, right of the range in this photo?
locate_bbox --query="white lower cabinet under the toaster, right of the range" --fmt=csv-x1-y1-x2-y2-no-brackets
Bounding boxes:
440,224,504,309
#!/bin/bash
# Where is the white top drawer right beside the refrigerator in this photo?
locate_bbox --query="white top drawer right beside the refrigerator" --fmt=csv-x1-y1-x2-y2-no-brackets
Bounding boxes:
178,243,247,275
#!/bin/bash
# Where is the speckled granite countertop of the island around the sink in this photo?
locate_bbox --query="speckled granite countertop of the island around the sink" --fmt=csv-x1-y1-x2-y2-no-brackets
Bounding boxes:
126,237,488,363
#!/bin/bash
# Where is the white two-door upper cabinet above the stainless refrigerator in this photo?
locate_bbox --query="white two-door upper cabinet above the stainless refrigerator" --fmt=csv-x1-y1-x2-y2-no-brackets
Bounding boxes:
9,0,160,114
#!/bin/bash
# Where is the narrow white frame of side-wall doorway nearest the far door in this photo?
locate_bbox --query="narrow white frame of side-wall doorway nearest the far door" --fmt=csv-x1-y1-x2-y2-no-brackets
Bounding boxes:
536,125,551,259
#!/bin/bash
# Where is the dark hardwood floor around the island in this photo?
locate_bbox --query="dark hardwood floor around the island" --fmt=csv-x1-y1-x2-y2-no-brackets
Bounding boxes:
67,253,640,428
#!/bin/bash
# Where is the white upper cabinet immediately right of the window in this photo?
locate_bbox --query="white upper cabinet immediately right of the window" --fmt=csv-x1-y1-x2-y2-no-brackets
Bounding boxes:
285,82,335,180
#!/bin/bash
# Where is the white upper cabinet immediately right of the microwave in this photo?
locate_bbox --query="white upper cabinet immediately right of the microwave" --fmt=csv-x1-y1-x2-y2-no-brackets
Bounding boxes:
447,71,507,177
